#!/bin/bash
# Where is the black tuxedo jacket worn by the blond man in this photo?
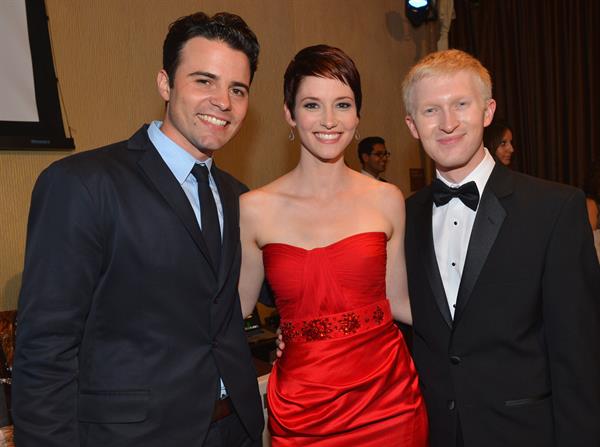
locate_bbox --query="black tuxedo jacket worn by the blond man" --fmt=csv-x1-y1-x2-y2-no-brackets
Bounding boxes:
406,165,600,447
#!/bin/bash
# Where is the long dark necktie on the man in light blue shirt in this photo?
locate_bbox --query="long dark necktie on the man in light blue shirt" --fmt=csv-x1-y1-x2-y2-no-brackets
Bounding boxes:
192,163,221,269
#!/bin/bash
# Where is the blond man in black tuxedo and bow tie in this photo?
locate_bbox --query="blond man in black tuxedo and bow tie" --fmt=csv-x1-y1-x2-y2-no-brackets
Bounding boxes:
403,50,600,447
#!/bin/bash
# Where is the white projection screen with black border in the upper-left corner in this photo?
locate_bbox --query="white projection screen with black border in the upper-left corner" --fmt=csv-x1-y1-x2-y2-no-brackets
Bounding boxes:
0,0,74,150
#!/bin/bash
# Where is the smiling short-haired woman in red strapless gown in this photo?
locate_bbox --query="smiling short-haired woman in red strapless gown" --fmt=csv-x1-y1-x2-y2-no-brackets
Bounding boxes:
240,45,427,447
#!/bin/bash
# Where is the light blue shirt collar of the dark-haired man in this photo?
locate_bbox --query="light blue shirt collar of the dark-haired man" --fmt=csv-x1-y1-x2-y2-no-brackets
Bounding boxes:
148,121,212,185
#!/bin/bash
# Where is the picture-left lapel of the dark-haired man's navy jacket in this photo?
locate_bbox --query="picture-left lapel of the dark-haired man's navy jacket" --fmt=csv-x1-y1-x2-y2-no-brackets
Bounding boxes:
129,128,217,276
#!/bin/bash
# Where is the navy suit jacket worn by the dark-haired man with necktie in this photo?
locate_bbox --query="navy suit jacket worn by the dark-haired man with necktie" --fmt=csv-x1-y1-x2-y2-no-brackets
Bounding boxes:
13,126,263,447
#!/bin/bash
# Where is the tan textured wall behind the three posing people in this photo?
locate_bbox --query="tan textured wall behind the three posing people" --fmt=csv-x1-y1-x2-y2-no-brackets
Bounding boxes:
0,0,437,310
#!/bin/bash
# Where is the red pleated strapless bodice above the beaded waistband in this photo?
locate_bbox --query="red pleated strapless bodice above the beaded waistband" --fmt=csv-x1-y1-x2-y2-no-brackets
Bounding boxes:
263,232,387,320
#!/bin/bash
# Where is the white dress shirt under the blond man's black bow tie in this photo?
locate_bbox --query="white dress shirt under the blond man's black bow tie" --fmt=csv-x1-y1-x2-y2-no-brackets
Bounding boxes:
431,149,495,318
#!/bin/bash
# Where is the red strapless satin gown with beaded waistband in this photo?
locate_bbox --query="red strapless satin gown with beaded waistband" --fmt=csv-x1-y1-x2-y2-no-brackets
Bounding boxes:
263,232,427,447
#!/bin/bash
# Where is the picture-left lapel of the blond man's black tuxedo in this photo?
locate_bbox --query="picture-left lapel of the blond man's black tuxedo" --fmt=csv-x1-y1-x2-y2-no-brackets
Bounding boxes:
415,191,452,328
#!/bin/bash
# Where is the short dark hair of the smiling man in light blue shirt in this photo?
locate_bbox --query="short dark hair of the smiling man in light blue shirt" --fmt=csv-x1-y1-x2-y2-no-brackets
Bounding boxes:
163,12,260,87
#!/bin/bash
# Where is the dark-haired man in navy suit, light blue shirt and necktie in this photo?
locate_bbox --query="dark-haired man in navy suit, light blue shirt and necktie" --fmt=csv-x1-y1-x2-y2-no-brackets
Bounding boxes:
13,13,263,447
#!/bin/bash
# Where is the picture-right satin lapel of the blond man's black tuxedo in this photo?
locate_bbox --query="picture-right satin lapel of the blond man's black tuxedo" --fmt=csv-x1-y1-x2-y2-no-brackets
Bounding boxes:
454,165,512,324
